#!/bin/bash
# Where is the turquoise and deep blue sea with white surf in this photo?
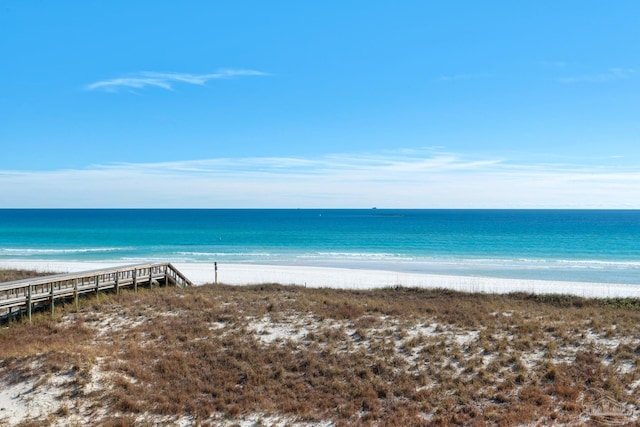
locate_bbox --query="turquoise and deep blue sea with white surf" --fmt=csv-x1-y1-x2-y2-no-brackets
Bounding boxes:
0,209,640,284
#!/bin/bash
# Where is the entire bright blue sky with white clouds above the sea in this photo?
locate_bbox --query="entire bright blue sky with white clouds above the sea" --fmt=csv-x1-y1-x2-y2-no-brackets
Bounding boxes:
0,0,640,208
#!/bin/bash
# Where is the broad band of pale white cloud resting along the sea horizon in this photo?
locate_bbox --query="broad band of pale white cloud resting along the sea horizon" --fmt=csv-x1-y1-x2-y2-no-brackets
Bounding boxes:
0,152,640,208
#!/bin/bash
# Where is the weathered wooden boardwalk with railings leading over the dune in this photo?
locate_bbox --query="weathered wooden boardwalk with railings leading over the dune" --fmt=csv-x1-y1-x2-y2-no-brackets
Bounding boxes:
0,263,193,320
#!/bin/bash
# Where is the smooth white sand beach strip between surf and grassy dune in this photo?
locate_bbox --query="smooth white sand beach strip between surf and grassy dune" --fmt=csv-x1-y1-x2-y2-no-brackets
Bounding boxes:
0,260,640,298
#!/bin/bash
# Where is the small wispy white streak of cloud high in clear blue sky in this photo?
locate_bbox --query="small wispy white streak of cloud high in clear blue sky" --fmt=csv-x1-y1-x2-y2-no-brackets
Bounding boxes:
85,69,267,92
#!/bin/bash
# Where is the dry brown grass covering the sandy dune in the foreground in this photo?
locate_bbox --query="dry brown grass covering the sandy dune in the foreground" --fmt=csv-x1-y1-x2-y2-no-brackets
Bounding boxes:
0,273,640,426
